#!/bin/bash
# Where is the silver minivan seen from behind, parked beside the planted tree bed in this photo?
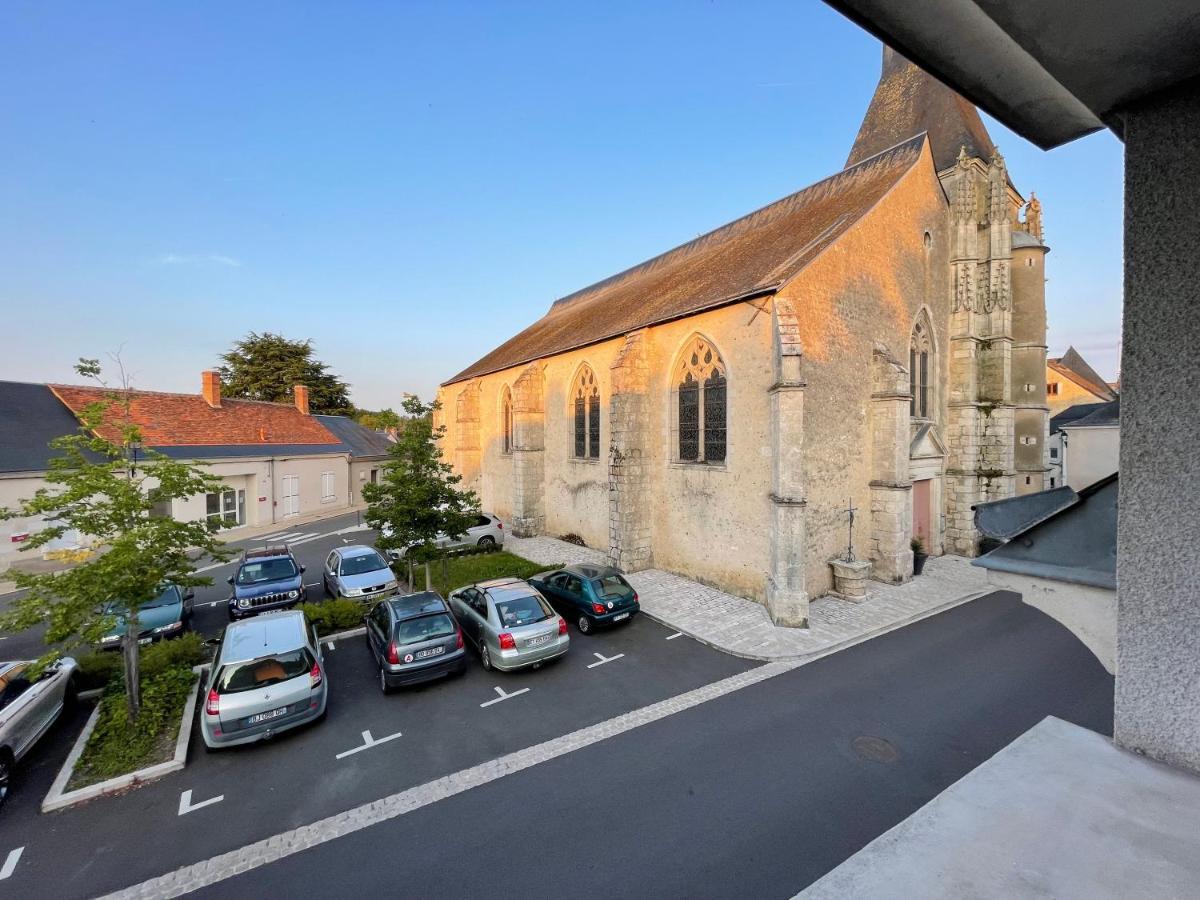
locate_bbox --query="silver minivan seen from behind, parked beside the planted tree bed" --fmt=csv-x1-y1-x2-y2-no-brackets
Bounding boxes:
200,610,329,750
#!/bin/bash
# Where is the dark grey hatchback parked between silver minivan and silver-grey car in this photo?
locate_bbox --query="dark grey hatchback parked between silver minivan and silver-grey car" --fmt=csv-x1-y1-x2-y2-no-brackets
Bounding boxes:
366,590,467,694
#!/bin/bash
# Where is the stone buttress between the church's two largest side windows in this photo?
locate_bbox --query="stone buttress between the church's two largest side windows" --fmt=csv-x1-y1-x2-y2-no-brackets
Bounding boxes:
608,329,654,572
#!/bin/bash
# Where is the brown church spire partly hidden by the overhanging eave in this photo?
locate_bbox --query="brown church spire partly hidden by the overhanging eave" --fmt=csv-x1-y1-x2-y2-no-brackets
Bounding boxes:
846,47,996,172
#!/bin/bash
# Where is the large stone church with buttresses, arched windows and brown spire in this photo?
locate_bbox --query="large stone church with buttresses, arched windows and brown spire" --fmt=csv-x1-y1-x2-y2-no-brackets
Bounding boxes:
438,49,1048,625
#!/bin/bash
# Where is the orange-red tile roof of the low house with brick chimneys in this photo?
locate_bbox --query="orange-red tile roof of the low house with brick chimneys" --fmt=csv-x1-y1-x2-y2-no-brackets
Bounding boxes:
49,384,338,446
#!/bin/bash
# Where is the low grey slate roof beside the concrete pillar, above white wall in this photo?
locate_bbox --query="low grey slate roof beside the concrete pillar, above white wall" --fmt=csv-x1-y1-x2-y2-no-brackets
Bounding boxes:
972,473,1117,590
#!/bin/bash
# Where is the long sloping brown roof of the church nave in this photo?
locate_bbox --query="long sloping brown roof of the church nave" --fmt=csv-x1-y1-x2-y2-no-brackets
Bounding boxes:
444,134,925,384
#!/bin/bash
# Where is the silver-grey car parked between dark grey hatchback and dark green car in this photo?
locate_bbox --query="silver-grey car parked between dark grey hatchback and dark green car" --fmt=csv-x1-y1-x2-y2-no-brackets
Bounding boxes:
450,578,571,672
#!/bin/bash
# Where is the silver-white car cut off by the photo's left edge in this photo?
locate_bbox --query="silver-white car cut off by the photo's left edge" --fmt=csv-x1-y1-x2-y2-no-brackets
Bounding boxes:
0,656,77,803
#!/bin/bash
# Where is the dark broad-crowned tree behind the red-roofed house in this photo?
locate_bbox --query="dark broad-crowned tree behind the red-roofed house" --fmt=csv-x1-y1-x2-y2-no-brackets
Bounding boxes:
217,331,354,415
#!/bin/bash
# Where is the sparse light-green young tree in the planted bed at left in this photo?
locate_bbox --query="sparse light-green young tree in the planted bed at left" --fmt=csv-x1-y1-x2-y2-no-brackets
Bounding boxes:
0,360,230,721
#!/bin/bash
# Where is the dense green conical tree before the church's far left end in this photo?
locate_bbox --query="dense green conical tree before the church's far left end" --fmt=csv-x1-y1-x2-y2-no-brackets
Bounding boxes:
362,395,479,589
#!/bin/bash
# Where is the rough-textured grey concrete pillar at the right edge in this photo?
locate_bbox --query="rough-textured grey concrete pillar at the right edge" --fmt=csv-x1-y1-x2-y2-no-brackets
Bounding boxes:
1115,82,1200,773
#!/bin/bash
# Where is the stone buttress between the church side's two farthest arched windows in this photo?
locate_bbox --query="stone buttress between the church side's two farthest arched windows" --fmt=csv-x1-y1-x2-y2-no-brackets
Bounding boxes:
512,362,546,538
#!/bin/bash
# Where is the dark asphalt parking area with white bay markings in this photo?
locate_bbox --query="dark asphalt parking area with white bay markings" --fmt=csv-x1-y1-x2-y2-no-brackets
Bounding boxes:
0,523,755,896
